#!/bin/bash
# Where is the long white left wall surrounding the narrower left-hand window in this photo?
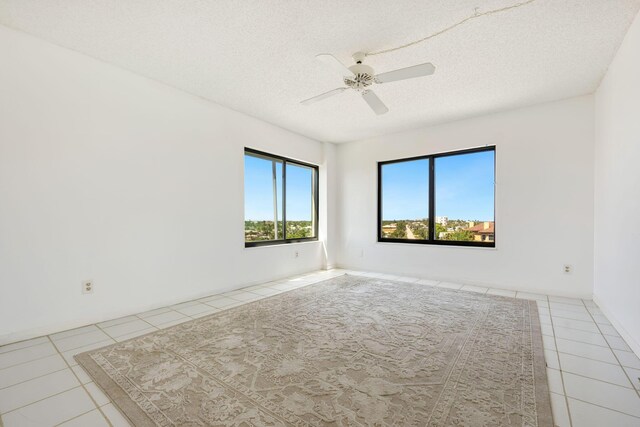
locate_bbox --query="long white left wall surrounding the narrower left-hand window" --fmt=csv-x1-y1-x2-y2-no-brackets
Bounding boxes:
0,27,335,344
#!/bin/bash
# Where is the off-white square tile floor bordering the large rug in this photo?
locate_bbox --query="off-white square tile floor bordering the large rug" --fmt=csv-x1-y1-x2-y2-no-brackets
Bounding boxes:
0,270,640,427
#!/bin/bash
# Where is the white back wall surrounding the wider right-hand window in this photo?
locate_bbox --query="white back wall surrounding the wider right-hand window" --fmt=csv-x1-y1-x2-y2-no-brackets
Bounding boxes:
338,96,594,297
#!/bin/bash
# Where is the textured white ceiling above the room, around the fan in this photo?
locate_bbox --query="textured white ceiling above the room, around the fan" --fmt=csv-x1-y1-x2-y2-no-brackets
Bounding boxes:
0,0,640,142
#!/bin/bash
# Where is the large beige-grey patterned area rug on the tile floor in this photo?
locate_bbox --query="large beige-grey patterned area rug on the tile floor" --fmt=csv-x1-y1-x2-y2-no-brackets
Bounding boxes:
76,275,552,427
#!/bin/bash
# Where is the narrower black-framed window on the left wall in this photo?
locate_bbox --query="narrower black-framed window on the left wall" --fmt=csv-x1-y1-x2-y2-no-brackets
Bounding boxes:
244,148,318,247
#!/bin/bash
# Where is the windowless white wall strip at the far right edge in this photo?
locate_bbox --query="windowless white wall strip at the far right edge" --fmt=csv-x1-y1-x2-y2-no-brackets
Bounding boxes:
594,11,640,355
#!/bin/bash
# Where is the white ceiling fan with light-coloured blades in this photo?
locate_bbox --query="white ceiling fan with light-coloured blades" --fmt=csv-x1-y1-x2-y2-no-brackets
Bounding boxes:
300,52,436,115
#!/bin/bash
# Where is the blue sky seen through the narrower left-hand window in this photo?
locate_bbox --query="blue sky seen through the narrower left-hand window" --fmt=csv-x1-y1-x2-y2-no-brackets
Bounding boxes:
244,155,312,221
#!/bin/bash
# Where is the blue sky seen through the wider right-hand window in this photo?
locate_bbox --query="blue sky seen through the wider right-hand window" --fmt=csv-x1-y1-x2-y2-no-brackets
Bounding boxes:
382,151,494,221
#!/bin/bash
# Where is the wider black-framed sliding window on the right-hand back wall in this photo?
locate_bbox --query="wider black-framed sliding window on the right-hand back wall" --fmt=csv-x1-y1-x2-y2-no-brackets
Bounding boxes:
378,147,495,247
